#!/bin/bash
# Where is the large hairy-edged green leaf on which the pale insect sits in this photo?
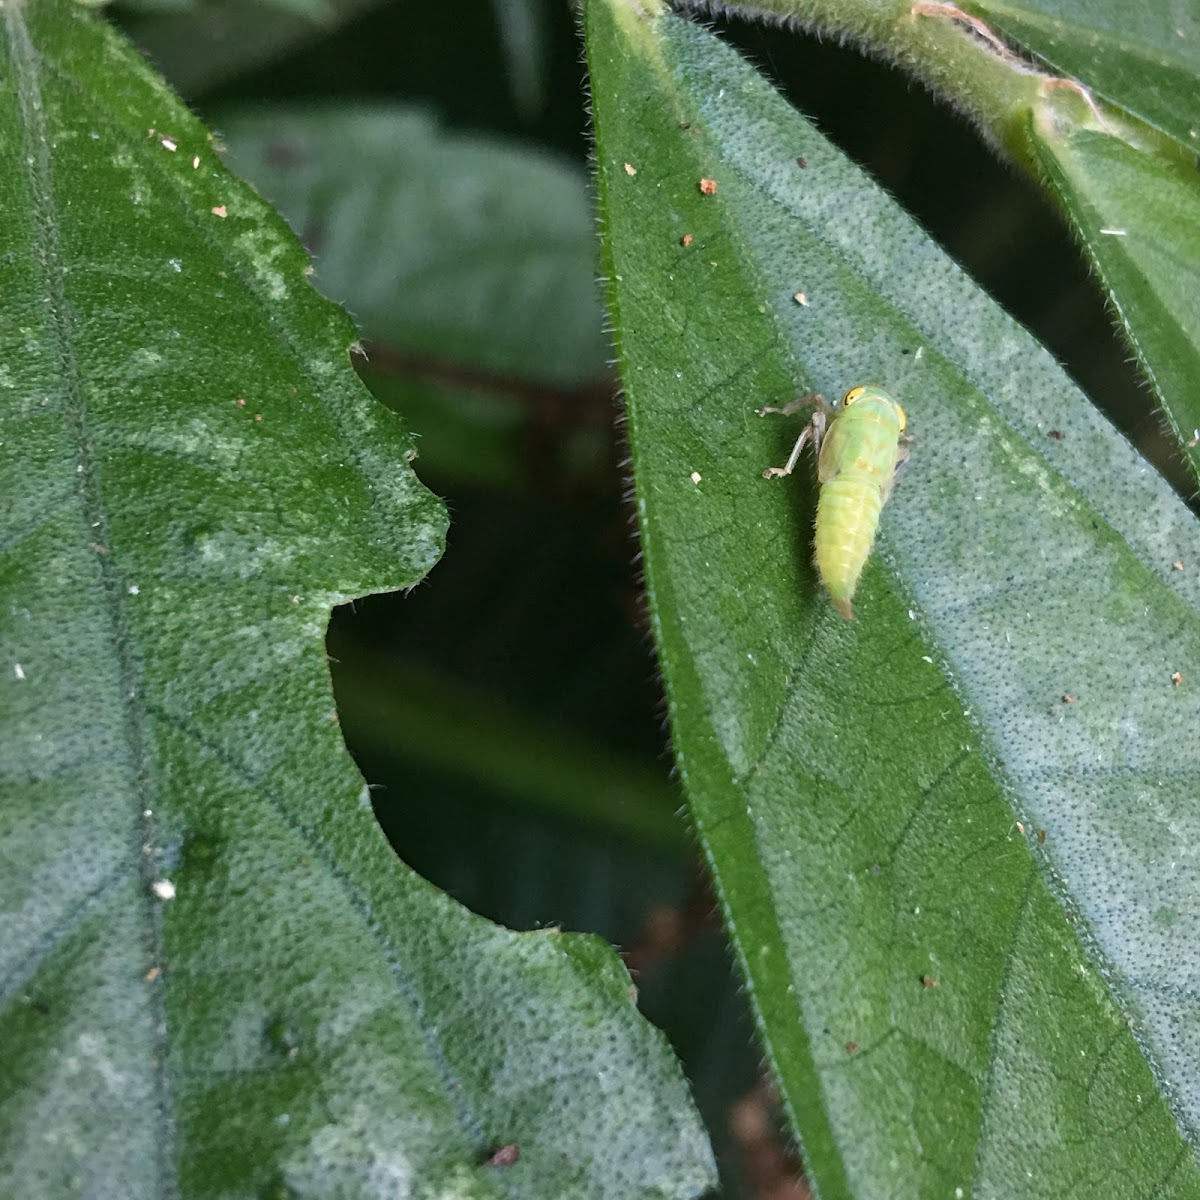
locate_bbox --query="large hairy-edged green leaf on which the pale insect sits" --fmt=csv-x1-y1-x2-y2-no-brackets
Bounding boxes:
587,0,1200,1198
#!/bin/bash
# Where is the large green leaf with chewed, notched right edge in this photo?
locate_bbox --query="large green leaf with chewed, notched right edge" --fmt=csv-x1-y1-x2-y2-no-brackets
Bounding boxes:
0,0,712,1200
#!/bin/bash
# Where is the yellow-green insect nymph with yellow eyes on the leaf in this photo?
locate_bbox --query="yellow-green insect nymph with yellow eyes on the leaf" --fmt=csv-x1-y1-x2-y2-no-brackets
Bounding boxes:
758,384,911,620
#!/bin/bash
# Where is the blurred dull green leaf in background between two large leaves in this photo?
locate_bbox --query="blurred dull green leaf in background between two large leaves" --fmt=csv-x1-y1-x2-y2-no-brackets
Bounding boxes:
222,106,607,385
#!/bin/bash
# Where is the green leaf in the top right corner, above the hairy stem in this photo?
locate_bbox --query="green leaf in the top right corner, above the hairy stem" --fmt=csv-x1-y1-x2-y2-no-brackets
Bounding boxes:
962,0,1200,154
